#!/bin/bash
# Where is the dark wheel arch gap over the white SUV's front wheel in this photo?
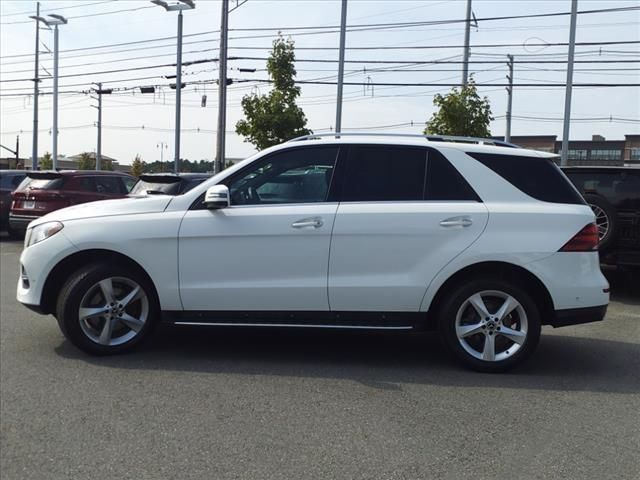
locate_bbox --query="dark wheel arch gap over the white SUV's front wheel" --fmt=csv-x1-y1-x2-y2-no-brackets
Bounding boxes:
40,249,158,314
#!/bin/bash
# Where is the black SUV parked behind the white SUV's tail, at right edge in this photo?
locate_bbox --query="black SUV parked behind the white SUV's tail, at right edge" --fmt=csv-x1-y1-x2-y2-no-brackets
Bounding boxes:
563,167,640,266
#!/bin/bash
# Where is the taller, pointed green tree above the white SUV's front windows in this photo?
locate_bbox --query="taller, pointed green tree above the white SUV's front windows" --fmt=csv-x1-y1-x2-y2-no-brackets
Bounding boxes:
236,35,312,150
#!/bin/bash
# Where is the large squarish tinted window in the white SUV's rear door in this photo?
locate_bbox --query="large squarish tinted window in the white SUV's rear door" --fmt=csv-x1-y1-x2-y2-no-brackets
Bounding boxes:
342,146,427,202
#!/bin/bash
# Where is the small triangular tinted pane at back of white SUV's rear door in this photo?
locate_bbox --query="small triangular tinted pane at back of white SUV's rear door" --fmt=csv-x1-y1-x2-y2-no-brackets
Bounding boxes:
425,150,480,202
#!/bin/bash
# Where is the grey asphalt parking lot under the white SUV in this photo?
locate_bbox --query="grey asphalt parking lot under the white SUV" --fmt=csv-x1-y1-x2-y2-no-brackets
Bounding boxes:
0,237,640,480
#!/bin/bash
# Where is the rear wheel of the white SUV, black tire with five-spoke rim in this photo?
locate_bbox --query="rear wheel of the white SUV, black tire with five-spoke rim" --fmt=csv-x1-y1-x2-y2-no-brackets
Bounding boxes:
437,277,541,373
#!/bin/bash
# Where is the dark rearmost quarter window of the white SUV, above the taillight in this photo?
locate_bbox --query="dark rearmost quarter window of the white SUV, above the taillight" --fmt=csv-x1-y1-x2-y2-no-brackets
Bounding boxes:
467,152,584,204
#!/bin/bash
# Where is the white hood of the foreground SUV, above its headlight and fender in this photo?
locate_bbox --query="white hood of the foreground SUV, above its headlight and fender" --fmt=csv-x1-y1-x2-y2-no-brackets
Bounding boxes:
32,195,173,226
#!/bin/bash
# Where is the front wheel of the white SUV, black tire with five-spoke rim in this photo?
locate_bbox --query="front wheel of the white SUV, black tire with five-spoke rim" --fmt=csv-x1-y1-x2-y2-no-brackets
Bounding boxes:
56,263,159,355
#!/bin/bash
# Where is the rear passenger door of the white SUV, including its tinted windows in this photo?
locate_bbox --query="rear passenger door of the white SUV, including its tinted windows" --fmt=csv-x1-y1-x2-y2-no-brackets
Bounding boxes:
328,146,488,312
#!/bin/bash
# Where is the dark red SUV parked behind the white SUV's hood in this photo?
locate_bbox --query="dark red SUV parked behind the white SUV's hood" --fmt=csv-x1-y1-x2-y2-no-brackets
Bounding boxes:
9,170,136,234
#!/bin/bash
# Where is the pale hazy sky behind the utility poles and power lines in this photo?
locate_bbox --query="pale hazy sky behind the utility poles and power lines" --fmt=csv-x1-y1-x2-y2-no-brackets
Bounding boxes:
0,0,640,164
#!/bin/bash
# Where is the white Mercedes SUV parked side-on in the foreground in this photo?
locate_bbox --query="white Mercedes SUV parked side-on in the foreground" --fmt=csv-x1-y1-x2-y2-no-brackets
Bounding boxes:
17,134,609,371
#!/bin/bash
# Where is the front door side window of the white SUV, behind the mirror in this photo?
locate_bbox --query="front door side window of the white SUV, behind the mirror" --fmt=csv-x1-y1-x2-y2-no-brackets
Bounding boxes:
227,147,338,205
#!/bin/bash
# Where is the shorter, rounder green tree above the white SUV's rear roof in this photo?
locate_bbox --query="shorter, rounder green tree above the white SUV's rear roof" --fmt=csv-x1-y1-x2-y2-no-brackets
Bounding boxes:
424,78,493,137
